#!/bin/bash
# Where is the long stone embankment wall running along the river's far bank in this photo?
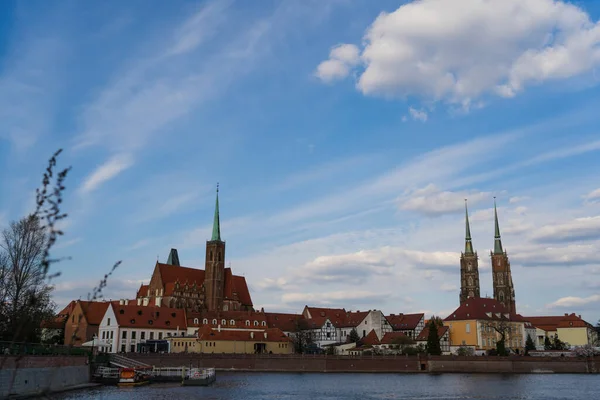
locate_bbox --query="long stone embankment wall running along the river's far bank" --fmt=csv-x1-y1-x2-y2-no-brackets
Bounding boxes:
128,353,600,374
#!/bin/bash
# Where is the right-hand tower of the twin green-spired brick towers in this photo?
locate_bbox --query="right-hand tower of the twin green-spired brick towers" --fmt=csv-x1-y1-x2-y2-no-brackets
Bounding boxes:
490,198,517,313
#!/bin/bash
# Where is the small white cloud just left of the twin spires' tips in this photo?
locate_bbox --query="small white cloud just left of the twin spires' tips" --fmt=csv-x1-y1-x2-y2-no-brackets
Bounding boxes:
400,184,492,215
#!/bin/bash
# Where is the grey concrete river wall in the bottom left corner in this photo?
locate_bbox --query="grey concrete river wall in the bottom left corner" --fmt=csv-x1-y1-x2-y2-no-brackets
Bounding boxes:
0,356,90,399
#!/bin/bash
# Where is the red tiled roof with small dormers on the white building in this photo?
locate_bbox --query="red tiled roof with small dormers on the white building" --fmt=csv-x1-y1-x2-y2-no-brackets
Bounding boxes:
112,302,187,330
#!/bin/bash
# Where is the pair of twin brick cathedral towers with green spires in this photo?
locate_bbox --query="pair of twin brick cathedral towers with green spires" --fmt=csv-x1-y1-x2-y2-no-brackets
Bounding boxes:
459,200,517,314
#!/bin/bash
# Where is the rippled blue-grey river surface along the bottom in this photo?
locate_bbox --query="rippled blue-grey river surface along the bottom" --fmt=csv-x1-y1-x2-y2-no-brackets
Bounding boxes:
51,372,600,400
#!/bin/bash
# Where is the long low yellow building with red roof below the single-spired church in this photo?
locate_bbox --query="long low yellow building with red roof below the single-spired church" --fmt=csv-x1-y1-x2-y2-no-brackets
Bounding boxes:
168,326,294,354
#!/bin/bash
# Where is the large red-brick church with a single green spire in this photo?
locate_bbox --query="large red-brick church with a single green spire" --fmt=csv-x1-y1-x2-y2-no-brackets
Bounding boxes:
136,187,253,312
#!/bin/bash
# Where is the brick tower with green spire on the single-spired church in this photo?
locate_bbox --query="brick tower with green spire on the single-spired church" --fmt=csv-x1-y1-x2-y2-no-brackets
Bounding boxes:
204,185,225,311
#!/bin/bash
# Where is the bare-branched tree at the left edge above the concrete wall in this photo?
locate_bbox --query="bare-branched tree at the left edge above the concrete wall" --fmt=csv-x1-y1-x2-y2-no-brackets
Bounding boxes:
0,215,54,342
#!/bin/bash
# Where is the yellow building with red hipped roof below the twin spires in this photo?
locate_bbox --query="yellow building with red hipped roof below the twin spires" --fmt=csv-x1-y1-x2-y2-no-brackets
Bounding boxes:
444,298,525,353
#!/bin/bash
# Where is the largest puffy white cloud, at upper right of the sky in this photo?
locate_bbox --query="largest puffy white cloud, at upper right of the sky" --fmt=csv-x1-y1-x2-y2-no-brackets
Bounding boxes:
322,0,600,108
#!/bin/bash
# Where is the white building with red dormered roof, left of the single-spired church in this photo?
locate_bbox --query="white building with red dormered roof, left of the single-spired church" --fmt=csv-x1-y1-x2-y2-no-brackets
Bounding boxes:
98,300,186,353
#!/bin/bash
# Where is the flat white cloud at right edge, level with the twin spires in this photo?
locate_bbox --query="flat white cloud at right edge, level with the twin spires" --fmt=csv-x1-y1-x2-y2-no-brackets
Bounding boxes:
532,216,600,242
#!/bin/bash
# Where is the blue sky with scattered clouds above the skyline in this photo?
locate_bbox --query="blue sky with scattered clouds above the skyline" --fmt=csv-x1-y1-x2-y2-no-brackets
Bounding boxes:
0,0,600,321
